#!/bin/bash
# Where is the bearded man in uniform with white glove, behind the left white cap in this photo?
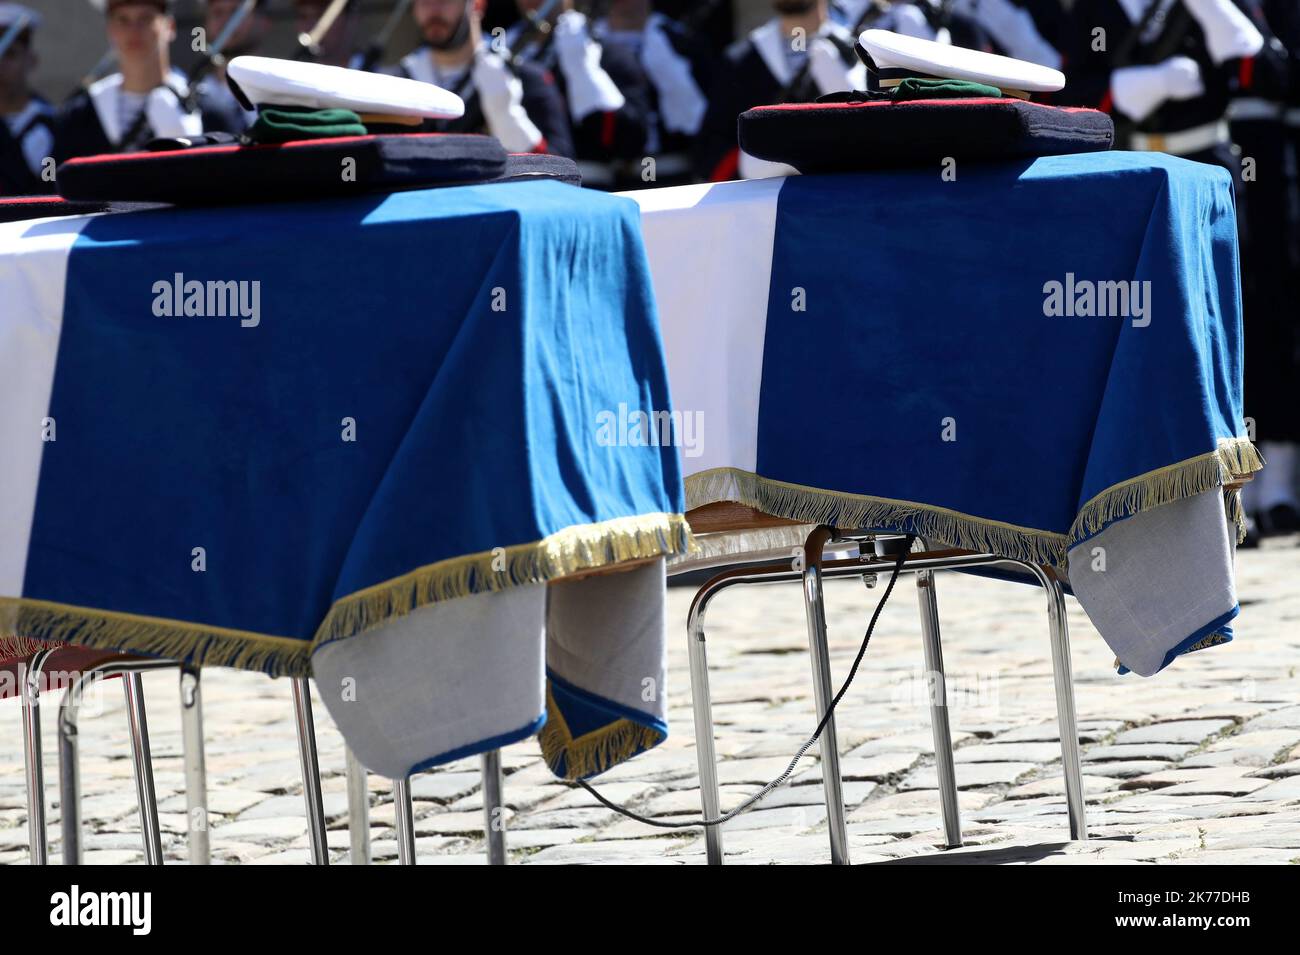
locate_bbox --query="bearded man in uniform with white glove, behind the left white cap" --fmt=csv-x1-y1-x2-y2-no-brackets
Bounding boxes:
393,0,573,157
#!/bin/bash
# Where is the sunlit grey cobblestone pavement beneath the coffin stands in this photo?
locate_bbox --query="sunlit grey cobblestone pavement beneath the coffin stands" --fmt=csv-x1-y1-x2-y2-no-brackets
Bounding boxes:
0,538,1300,864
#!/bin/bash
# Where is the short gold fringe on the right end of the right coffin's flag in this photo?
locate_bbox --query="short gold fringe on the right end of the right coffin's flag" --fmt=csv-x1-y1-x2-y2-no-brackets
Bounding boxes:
1070,438,1264,541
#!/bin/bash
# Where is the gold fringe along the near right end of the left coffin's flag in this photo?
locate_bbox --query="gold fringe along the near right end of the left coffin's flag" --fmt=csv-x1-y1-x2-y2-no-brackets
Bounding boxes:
312,513,692,652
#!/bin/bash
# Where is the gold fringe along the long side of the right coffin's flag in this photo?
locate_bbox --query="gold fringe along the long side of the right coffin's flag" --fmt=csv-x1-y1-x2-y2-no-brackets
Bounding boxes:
686,468,1066,567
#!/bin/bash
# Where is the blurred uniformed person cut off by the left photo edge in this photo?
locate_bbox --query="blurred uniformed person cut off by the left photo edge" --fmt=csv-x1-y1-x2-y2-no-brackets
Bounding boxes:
0,3,55,196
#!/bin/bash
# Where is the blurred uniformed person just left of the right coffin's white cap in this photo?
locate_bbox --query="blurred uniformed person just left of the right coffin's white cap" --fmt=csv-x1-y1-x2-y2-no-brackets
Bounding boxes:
696,0,866,182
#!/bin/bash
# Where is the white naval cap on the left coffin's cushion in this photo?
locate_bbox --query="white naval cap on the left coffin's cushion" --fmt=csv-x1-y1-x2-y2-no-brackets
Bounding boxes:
226,56,465,120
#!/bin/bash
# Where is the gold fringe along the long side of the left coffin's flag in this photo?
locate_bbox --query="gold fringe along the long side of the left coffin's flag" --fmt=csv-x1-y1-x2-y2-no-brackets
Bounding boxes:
0,596,311,677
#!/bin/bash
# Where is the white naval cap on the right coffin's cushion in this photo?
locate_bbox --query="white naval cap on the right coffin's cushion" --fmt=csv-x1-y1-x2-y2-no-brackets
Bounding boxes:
858,30,1065,94
